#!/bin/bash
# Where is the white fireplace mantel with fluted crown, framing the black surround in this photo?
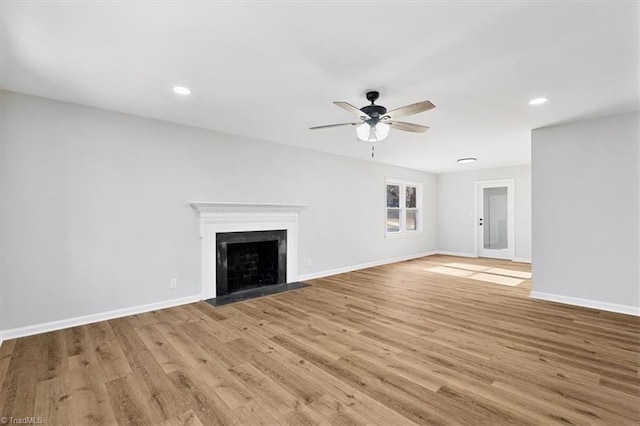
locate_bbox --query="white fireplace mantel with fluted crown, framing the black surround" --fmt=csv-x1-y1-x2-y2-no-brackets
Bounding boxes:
191,201,306,299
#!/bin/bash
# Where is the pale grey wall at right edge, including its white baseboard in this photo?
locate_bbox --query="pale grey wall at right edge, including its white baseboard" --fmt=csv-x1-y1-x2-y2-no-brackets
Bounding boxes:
532,113,640,315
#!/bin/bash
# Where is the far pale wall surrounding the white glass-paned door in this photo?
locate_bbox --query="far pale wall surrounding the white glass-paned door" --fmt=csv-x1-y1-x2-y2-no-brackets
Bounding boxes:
436,165,531,261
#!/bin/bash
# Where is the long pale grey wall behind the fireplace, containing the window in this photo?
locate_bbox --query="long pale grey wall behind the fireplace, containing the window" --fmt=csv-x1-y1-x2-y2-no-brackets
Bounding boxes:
0,92,436,330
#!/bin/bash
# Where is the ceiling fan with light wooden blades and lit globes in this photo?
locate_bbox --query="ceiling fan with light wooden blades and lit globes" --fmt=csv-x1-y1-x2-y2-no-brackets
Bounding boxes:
310,91,436,142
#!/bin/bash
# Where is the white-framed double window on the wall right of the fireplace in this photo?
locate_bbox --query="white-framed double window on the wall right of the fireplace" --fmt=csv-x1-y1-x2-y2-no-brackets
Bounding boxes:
386,179,422,236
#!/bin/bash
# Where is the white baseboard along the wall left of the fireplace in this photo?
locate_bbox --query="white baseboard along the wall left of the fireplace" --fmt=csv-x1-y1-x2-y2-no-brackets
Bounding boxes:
0,294,202,341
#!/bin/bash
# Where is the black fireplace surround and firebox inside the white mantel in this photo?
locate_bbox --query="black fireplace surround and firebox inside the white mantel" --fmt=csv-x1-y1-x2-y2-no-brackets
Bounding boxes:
216,230,287,296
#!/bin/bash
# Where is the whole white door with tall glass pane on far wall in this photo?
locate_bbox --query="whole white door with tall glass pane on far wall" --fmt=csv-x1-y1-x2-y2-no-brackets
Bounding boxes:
476,179,515,260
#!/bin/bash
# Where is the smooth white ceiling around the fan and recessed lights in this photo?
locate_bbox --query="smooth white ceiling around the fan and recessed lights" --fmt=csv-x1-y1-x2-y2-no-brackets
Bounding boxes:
0,1,640,172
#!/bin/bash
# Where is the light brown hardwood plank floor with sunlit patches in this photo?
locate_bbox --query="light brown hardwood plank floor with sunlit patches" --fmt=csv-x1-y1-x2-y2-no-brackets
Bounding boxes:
0,256,640,425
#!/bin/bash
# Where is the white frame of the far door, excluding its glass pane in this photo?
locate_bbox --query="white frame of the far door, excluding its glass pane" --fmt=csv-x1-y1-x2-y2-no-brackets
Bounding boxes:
473,178,516,260
